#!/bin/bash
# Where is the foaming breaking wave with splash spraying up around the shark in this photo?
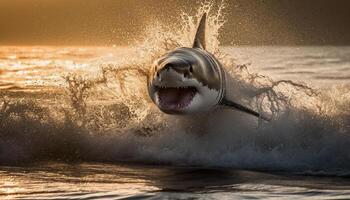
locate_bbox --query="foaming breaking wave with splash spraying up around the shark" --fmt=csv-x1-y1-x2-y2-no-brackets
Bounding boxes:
0,2,350,173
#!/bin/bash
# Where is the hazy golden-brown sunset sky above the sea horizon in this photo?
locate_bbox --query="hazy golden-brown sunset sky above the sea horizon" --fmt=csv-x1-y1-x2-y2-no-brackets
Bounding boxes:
0,0,350,45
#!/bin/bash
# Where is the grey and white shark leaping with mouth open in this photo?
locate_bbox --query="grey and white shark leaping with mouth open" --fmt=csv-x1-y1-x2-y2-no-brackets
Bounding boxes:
148,14,269,121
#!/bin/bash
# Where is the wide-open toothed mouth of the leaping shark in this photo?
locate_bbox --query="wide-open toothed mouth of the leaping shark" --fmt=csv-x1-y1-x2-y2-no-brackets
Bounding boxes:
156,86,197,111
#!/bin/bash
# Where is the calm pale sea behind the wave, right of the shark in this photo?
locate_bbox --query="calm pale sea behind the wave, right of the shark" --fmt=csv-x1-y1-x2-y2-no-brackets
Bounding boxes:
227,46,350,88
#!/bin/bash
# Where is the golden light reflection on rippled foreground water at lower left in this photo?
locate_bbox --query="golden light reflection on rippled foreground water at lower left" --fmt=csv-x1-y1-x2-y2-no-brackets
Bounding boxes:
0,164,159,199
